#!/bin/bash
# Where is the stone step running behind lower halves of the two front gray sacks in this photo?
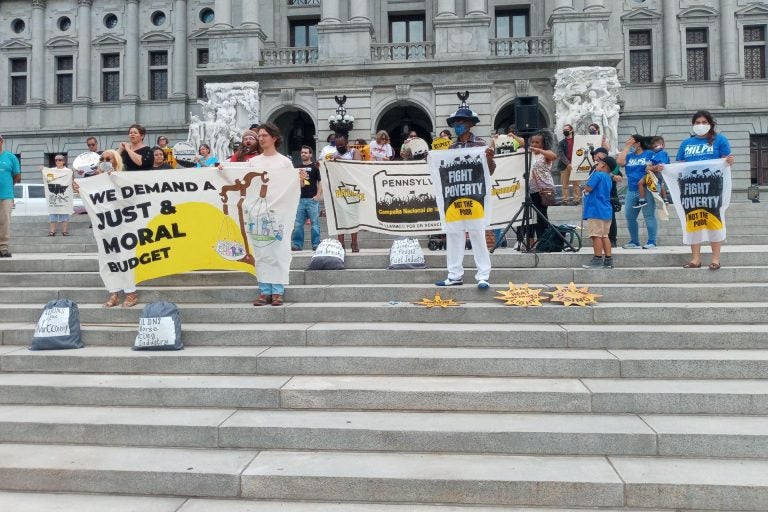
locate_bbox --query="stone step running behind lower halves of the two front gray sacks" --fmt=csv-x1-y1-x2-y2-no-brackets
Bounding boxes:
0,322,768,350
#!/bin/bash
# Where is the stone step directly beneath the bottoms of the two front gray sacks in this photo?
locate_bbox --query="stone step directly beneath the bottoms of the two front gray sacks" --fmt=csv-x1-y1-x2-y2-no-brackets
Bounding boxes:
0,345,768,379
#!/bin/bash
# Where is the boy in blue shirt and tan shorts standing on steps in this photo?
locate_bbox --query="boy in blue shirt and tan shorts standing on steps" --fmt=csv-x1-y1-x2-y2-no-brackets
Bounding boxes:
583,156,616,269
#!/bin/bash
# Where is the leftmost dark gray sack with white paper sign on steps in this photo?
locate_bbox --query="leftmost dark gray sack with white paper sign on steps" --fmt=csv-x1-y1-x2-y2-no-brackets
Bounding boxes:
29,299,85,350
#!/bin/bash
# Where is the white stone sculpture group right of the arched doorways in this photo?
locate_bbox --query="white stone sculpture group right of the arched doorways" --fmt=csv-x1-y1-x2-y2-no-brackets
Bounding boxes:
554,66,621,152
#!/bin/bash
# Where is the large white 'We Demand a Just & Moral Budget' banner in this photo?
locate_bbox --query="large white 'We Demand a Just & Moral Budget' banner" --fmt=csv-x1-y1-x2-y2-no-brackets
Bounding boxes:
78,166,299,291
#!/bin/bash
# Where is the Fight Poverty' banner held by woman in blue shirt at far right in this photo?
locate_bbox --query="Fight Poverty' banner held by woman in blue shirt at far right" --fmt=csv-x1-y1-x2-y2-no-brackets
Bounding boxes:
662,159,731,245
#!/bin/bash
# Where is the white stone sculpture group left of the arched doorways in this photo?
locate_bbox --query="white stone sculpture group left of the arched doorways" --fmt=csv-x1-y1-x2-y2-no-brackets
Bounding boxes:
187,82,259,160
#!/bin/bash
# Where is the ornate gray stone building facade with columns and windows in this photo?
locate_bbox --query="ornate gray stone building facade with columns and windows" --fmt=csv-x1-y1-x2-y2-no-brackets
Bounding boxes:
0,0,768,189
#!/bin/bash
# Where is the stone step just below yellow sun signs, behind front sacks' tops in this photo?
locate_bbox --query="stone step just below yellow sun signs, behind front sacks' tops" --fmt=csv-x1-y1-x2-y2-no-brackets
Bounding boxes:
0,300,768,324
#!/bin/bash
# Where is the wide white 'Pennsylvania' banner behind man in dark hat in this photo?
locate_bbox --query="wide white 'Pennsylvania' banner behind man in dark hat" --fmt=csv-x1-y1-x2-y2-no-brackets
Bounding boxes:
321,148,525,235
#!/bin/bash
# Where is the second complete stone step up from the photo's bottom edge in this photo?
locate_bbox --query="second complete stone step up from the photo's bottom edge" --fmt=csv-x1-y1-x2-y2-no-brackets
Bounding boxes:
0,405,768,458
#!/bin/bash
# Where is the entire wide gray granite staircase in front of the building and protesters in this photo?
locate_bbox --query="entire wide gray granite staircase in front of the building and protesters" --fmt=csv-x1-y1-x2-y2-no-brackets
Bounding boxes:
0,203,768,512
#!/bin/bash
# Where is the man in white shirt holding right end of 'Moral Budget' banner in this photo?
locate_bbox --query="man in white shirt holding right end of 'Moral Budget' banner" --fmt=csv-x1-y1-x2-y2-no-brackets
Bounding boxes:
248,123,296,306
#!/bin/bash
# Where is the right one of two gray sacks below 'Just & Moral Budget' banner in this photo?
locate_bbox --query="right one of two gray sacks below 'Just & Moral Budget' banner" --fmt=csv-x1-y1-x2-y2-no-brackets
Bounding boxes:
133,302,184,350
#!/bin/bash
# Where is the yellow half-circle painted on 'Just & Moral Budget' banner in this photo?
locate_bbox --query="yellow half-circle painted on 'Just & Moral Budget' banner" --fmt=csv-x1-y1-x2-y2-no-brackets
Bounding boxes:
134,202,255,283
